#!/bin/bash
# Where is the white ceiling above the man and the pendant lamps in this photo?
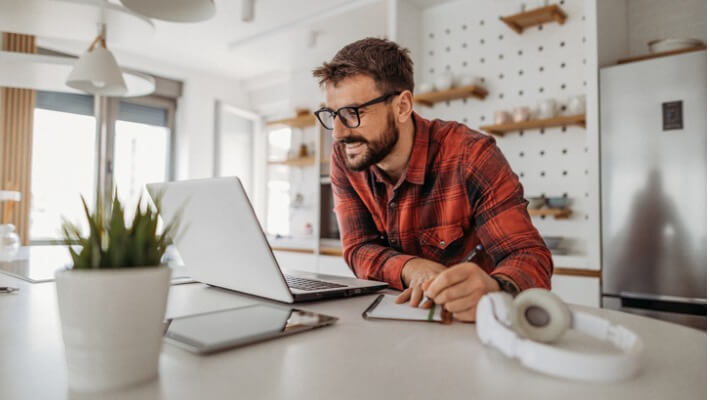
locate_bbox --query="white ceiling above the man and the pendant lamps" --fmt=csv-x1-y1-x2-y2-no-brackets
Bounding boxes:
0,0,451,84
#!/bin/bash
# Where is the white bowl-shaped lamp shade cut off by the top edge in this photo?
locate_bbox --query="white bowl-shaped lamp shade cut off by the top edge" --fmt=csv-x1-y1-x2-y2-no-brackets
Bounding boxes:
121,0,216,22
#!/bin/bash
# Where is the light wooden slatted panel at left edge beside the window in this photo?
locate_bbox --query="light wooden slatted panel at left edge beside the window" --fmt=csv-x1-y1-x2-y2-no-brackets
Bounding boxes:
0,33,37,245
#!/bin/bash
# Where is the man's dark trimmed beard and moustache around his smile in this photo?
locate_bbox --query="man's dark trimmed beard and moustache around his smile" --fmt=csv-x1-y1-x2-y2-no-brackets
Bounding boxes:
338,112,399,171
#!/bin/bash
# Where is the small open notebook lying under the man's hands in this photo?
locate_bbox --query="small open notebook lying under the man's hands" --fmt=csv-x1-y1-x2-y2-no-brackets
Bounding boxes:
362,294,451,324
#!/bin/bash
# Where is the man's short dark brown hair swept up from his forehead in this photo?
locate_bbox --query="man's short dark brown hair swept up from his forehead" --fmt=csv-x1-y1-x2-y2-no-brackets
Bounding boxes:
313,37,414,94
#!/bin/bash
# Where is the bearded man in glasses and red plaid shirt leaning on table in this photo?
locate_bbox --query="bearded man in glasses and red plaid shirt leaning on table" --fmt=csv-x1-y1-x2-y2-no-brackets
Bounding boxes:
313,38,552,321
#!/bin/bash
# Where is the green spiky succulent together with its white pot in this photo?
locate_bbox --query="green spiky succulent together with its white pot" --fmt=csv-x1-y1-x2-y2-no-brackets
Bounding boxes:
55,194,177,392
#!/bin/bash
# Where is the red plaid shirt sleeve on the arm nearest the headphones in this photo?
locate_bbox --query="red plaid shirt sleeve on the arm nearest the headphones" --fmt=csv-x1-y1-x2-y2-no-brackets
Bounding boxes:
462,138,553,290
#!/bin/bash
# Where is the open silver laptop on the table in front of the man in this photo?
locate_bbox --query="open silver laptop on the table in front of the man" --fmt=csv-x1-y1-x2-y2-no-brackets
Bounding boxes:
146,177,387,303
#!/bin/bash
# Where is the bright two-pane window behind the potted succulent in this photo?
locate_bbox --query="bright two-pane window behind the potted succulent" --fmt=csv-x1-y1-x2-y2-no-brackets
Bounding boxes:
30,91,175,244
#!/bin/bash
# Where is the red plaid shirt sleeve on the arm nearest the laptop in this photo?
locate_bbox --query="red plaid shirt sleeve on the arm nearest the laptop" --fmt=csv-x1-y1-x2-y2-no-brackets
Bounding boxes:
330,151,415,290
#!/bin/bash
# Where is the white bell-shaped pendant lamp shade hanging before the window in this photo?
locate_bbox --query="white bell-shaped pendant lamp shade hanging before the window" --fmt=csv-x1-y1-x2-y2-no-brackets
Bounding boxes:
67,46,127,96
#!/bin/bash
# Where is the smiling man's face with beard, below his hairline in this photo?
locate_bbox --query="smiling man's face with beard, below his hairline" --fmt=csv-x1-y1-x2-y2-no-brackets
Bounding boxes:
326,75,399,171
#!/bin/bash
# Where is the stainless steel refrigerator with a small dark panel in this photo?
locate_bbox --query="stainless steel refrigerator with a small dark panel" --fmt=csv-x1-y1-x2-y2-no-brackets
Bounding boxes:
599,51,707,329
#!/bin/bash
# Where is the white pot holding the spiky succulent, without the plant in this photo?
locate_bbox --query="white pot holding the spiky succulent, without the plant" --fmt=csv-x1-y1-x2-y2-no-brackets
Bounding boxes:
55,266,170,392
